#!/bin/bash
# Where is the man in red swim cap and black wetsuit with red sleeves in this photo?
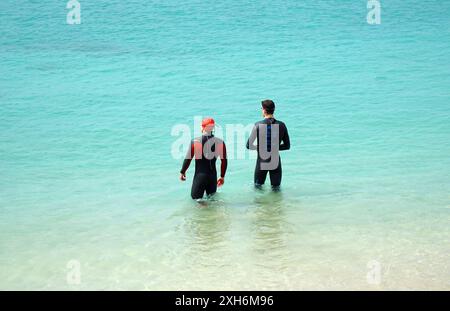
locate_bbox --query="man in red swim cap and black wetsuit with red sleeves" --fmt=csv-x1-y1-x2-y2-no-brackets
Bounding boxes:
180,118,228,200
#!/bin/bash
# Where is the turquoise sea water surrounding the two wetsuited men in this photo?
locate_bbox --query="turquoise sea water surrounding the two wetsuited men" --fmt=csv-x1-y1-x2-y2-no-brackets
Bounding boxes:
0,0,450,290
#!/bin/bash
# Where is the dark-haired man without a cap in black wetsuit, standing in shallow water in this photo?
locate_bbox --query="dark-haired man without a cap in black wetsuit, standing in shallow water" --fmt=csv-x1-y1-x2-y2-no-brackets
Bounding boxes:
247,99,291,190
